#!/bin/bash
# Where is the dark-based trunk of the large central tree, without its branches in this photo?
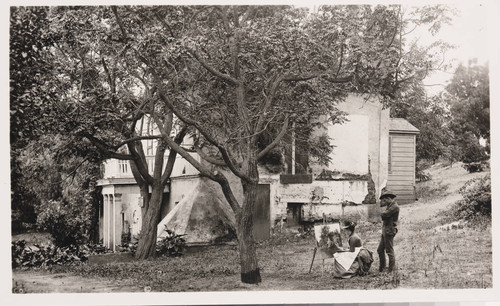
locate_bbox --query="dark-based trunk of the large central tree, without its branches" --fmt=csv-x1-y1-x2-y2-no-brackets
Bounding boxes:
236,162,262,284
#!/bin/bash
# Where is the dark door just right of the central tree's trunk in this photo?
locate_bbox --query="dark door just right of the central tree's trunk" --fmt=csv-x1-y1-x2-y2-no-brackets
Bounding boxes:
253,184,271,241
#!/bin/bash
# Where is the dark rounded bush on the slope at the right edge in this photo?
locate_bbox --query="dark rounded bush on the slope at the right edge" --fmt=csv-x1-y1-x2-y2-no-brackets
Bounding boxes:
452,175,491,221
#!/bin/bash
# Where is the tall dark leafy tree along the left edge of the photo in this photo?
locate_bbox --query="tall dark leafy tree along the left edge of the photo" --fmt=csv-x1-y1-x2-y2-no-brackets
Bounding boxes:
9,7,54,231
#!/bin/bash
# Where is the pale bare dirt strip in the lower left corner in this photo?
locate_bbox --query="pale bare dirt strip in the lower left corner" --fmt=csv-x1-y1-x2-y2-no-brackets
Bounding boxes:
12,271,144,293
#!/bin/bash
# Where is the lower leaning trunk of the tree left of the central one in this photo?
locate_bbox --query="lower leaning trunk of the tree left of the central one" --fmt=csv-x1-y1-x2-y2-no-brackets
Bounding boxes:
135,184,165,259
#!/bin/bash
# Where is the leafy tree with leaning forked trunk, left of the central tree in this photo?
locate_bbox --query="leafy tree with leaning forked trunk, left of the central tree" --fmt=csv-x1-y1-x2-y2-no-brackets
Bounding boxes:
25,7,193,259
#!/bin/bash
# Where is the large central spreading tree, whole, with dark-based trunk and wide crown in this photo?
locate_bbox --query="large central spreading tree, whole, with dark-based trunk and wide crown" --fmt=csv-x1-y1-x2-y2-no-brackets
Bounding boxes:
105,6,450,283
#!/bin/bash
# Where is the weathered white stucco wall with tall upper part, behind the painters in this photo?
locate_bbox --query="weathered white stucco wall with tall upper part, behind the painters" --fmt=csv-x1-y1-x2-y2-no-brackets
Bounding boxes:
261,95,389,226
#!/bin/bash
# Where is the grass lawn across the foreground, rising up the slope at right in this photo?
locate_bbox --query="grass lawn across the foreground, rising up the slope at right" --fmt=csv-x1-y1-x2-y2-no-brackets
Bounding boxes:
14,165,492,292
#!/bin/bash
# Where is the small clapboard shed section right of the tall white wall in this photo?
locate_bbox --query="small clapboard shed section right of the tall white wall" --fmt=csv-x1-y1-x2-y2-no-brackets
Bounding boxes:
387,118,420,204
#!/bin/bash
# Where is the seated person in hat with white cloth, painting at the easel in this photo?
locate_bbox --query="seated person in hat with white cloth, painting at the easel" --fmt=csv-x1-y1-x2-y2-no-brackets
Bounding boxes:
333,220,373,278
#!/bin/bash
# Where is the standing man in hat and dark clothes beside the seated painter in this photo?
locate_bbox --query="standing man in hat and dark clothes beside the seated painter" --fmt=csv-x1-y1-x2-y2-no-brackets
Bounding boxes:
377,190,399,272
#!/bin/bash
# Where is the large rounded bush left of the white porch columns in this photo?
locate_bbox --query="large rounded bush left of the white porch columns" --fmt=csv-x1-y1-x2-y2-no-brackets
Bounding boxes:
19,136,99,246
